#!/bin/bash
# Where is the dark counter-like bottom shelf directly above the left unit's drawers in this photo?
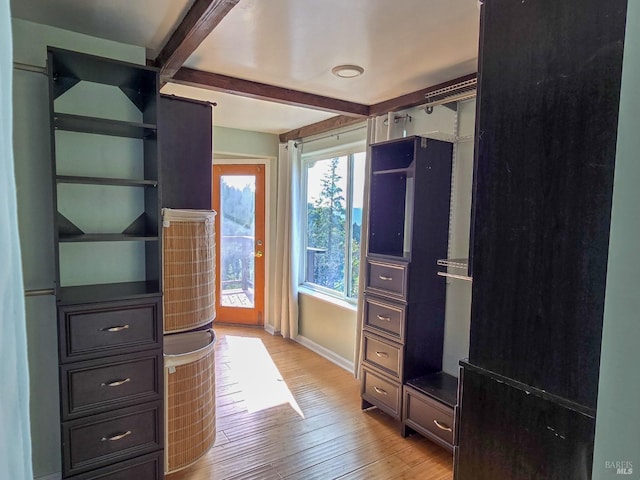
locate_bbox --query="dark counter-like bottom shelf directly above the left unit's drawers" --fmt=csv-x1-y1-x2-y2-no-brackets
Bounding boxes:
58,282,162,305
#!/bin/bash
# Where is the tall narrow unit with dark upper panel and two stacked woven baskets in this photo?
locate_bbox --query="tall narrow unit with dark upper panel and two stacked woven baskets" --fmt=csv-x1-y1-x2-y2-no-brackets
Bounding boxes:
158,95,216,474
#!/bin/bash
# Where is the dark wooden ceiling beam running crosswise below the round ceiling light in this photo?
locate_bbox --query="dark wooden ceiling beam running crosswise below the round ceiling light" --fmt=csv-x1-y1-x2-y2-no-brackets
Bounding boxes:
167,67,369,119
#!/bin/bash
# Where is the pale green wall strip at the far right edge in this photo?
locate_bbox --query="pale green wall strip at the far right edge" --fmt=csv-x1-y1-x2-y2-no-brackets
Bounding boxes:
593,1,640,480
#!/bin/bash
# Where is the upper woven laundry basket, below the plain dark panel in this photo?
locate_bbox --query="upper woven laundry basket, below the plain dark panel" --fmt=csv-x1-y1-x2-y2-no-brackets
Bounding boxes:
162,208,216,333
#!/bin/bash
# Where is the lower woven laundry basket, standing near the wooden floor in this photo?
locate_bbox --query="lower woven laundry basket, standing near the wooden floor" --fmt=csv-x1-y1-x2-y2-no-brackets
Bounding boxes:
164,330,216,473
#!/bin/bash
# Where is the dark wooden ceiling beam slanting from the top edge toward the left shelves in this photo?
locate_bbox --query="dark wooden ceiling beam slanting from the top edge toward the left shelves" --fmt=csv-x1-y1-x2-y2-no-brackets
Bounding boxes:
155,0,240,80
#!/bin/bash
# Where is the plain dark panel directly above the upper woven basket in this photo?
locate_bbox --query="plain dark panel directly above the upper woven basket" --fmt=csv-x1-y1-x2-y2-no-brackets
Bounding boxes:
158,96,213,210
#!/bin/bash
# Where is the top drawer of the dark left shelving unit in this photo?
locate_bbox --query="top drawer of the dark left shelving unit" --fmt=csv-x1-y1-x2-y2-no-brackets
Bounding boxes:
58,297,162,363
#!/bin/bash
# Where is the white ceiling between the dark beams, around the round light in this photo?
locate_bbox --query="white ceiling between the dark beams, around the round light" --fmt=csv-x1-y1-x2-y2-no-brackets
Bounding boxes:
11,0,479,133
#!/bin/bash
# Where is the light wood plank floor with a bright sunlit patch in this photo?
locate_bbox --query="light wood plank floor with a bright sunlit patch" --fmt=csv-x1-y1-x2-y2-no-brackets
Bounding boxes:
167,326,452,480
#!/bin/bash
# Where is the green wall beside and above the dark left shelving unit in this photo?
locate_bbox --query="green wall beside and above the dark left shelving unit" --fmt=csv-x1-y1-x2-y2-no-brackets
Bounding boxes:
12,19,145,478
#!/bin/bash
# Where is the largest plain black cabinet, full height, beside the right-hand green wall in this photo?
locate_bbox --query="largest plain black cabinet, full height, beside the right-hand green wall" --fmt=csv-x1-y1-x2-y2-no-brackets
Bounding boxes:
455,0,626,480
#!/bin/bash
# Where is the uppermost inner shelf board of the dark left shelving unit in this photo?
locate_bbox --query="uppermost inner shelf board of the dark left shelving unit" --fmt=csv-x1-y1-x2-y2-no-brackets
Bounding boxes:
53,112,156,138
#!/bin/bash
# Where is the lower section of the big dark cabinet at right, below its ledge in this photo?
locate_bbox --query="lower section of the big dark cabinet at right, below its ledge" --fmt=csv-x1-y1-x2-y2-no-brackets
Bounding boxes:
455,368,595,480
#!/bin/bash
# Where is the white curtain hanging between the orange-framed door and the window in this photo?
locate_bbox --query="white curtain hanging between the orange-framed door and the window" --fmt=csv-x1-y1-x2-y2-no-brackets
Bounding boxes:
273,141,302,338
